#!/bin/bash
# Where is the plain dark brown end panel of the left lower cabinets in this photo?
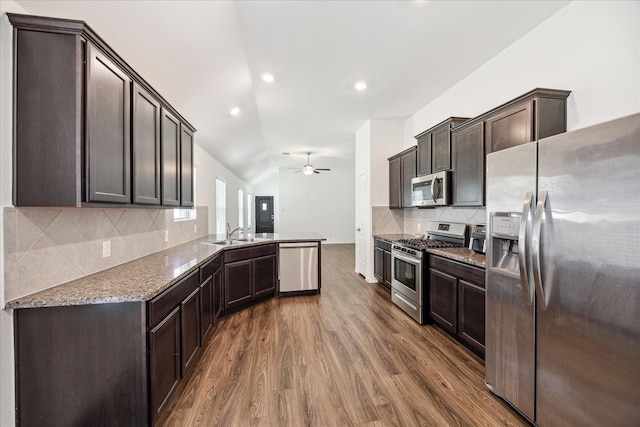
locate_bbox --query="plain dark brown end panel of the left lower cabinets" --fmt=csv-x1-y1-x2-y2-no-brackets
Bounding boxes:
15,301,148,427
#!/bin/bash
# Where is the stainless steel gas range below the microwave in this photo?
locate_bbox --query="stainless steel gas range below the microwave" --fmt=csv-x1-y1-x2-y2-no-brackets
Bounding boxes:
391,221,469,325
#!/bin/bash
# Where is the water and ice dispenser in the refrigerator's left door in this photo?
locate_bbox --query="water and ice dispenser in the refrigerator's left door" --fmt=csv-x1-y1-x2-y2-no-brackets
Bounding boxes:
490,212,522,276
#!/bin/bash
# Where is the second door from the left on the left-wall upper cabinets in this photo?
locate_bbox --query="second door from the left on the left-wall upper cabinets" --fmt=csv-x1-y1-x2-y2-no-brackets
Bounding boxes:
132,84,161,205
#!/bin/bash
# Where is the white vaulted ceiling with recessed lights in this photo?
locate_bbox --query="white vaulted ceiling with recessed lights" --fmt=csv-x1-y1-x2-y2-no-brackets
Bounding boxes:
15,0,568,184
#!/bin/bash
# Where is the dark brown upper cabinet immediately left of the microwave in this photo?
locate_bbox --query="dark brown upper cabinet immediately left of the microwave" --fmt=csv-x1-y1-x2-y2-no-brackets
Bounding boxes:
388,146,416,209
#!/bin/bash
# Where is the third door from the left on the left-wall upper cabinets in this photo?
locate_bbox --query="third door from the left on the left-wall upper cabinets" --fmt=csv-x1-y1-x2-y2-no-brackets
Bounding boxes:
162,110,180,206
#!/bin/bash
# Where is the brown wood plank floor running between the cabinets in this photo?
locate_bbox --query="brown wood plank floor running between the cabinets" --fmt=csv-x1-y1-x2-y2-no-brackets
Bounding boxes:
161,245,528,427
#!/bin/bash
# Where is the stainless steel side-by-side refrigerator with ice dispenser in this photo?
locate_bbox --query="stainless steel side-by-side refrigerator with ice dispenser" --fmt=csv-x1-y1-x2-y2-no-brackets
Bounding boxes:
485,114,640,427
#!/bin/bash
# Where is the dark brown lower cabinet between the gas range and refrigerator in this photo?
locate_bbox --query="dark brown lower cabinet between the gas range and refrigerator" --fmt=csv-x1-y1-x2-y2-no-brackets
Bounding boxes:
429,255,485,358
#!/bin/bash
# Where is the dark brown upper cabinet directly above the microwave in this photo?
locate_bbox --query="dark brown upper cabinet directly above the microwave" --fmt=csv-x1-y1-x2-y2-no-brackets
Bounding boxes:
415,117,468,176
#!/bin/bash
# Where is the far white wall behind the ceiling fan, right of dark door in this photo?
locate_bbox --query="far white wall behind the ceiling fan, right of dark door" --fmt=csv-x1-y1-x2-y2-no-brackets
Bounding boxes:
279,160,355,243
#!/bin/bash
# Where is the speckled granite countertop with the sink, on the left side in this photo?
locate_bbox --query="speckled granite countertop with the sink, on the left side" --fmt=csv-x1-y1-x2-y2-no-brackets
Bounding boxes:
5,233,326,309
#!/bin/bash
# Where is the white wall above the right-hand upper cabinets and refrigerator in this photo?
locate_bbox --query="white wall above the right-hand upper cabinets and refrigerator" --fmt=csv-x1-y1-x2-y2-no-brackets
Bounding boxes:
404,1,640,147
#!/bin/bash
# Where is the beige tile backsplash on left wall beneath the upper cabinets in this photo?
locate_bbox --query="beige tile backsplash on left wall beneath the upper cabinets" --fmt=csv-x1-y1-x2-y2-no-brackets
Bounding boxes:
3,206,209,301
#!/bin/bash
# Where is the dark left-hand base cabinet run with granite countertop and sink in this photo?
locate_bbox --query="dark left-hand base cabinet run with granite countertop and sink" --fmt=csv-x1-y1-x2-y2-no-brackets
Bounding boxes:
6,233,325,426
